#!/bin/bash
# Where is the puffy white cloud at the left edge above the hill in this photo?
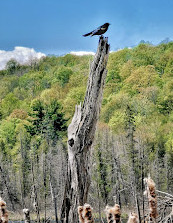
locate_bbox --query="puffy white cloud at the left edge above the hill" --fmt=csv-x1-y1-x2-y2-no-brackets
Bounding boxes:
0,46,46,70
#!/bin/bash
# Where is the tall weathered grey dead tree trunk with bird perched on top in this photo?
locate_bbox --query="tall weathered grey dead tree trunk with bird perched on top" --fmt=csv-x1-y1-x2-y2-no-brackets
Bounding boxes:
61,37,109,223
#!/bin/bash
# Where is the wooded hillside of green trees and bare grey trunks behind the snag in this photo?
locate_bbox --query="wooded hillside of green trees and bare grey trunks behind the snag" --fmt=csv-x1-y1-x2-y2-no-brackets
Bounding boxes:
0,42,173,219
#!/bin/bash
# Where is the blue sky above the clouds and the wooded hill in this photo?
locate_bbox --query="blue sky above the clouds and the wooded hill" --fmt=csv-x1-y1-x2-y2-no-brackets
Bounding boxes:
0,0,173,55
